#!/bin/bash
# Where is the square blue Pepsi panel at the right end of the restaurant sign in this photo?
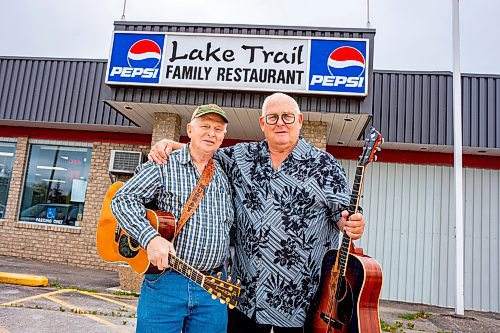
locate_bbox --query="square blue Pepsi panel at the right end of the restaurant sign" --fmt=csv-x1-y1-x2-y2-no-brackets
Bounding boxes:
308,39,368,96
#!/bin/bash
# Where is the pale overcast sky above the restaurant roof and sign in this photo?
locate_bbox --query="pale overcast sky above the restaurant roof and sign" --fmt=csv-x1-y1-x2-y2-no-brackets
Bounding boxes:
0,0,500,74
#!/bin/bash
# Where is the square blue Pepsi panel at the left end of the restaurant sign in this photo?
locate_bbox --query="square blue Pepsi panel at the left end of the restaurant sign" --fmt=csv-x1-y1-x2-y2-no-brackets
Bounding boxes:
106,32,165,84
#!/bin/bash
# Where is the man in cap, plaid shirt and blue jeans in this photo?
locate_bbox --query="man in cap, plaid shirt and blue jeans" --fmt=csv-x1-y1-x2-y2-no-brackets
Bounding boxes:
111,104,234,333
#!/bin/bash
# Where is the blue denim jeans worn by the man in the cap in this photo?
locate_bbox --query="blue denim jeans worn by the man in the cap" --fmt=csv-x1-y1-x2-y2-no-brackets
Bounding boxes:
136,269,227,333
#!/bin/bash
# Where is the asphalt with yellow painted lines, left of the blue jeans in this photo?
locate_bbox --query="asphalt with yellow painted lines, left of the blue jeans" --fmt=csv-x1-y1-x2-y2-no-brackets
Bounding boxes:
0,284,137,333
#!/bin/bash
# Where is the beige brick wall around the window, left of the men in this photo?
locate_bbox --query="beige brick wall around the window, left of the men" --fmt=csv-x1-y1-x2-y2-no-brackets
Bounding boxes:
0,115,184,270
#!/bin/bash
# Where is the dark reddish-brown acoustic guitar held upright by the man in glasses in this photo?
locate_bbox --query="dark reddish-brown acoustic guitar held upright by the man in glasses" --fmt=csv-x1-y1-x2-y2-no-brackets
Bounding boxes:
305,127,382,333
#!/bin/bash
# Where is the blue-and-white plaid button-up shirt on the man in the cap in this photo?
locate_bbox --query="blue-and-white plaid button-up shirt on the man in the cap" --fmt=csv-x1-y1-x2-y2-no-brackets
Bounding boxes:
111,145,234,270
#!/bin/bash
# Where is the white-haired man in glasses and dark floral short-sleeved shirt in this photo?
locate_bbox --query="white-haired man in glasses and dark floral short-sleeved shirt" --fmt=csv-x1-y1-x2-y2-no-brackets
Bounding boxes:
149,93,365,333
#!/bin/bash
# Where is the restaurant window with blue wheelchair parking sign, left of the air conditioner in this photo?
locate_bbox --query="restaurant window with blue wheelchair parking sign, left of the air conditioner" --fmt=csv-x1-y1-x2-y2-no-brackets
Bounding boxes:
19,144,92,227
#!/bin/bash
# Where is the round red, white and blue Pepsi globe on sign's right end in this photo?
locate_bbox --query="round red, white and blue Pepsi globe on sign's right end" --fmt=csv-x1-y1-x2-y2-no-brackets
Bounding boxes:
327,46,365,77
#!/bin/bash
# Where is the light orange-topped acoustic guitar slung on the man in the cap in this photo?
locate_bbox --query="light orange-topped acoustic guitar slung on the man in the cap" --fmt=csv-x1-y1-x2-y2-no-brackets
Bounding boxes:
97,182,241,309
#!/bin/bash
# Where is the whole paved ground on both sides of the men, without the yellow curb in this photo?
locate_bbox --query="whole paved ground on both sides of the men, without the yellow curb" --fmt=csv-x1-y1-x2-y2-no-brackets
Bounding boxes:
0,256,500,333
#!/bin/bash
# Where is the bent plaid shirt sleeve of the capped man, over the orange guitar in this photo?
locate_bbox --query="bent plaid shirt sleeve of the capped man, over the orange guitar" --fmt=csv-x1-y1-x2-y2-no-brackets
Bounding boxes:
111,162,163,248
